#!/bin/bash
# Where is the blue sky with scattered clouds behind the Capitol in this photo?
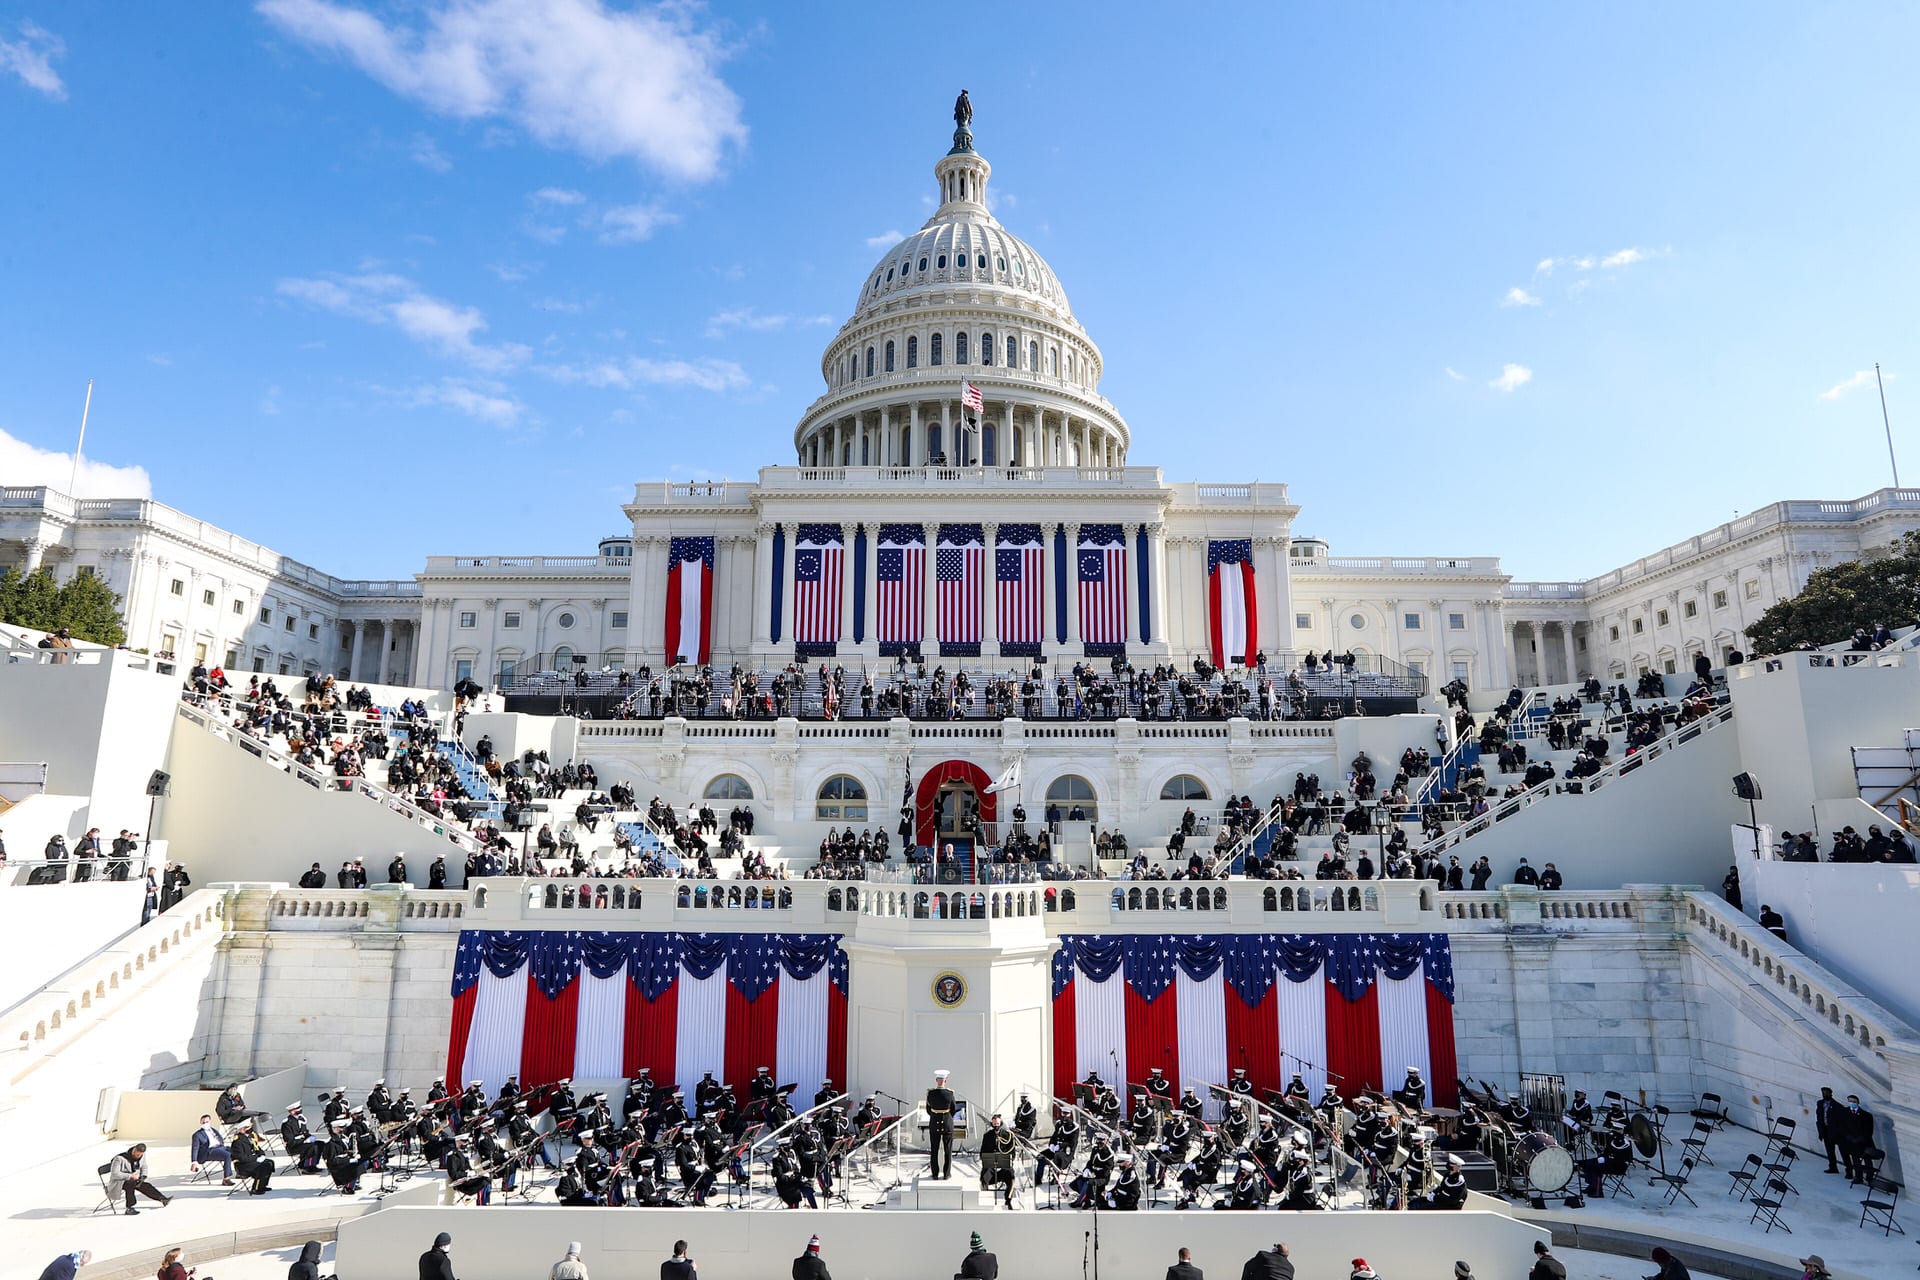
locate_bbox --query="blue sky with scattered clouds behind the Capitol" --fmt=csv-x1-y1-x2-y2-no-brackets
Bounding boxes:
0,0,1920,578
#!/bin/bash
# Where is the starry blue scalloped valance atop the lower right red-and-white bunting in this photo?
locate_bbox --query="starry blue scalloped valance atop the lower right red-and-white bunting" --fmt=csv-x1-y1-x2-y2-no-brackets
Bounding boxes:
1054,933,1453,1004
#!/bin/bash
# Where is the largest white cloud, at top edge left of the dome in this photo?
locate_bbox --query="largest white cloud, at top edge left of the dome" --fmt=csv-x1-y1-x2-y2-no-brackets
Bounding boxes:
255,0,747,182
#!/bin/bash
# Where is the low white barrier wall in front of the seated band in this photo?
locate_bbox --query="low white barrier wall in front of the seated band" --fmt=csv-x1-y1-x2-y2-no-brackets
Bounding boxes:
336,1207,1548,1280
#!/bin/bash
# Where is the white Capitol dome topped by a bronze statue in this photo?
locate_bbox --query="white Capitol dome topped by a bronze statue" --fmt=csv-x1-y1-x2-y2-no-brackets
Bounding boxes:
793,94,1129,468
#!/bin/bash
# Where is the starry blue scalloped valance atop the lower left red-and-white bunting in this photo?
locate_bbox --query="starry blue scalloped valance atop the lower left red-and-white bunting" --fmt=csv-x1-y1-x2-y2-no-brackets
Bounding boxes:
453,929,847,1000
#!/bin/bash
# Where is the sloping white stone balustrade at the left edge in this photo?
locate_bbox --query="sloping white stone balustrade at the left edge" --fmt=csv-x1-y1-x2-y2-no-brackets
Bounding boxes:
0,889,225,1082
